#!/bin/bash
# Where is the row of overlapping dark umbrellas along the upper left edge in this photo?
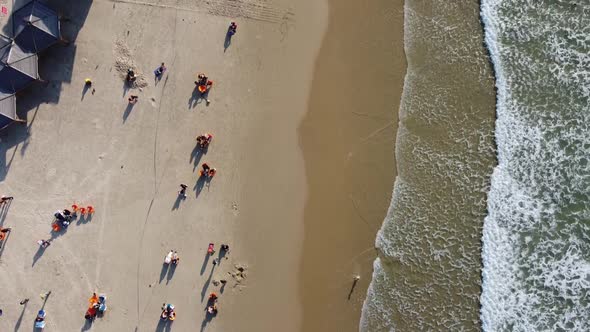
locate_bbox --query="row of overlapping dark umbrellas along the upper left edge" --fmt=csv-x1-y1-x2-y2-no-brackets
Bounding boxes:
0,0,61,129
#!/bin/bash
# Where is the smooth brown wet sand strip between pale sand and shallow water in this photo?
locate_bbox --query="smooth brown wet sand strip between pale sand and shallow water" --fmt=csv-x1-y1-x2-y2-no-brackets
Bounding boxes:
299,1,405,331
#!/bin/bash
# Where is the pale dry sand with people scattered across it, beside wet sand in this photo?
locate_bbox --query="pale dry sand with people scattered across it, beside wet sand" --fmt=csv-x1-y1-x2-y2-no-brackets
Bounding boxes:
0,0,327,331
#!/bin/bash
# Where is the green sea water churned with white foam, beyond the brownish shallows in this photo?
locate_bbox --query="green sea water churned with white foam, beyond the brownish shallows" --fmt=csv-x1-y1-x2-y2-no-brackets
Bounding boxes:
481,0,590,331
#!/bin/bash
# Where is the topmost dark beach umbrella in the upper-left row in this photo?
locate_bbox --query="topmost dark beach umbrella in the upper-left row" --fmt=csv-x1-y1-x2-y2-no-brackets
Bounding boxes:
12,0,60,53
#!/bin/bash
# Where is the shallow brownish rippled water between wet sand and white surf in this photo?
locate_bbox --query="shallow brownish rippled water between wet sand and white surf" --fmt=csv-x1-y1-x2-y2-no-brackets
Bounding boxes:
360,0,496,332
